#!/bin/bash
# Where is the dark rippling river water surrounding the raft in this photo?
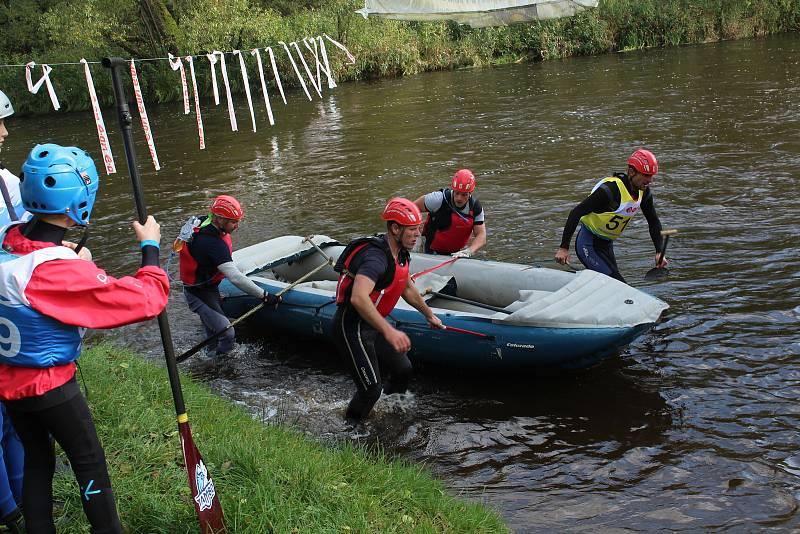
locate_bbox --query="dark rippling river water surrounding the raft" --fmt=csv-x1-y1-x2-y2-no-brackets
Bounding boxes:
3,34,800,532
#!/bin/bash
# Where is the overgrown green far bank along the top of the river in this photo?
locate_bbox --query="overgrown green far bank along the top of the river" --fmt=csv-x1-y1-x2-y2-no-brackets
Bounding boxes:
0,0,800,112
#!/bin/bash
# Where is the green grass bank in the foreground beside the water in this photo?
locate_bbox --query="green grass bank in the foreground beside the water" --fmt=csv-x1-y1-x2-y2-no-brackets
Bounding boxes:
55,344,507,534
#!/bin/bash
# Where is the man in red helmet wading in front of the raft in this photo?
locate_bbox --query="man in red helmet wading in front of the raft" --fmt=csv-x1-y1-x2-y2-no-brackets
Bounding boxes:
333,198,442,423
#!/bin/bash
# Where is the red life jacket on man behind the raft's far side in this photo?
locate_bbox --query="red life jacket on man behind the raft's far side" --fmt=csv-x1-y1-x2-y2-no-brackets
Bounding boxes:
422,189,480,254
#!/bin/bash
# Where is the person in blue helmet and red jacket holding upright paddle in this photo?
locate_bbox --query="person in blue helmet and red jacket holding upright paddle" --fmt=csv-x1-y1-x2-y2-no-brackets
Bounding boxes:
0,144,169,533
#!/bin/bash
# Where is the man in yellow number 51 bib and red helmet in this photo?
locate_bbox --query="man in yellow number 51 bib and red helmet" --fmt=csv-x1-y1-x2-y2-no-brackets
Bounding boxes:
556,149,668,282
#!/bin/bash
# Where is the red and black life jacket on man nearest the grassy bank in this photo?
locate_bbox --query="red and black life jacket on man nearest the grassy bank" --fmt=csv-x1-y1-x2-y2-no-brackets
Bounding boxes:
333,236,411,317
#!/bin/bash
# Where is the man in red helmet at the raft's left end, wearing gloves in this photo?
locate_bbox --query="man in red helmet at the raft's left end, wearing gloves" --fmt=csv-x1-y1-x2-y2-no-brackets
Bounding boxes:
176,195,280,361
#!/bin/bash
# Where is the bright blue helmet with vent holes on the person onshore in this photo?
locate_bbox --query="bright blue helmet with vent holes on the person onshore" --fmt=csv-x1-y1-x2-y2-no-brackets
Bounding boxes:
19,143,100,225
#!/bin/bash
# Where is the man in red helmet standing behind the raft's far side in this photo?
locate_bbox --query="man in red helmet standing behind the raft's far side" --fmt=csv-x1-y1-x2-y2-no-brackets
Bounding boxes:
414,169,486,258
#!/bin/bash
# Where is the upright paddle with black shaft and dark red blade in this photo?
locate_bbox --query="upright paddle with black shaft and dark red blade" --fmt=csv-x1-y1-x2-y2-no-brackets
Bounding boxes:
103,57,226,534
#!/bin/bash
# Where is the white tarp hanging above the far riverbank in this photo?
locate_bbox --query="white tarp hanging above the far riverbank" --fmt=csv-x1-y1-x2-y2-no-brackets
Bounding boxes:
358,0,599,28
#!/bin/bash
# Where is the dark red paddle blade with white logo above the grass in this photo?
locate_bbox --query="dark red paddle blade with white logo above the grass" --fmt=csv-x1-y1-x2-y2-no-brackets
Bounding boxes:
178,422,225,534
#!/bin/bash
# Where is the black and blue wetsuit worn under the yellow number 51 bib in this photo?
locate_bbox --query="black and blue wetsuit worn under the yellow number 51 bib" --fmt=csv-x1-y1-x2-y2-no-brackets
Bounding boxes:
561,173,661,282
